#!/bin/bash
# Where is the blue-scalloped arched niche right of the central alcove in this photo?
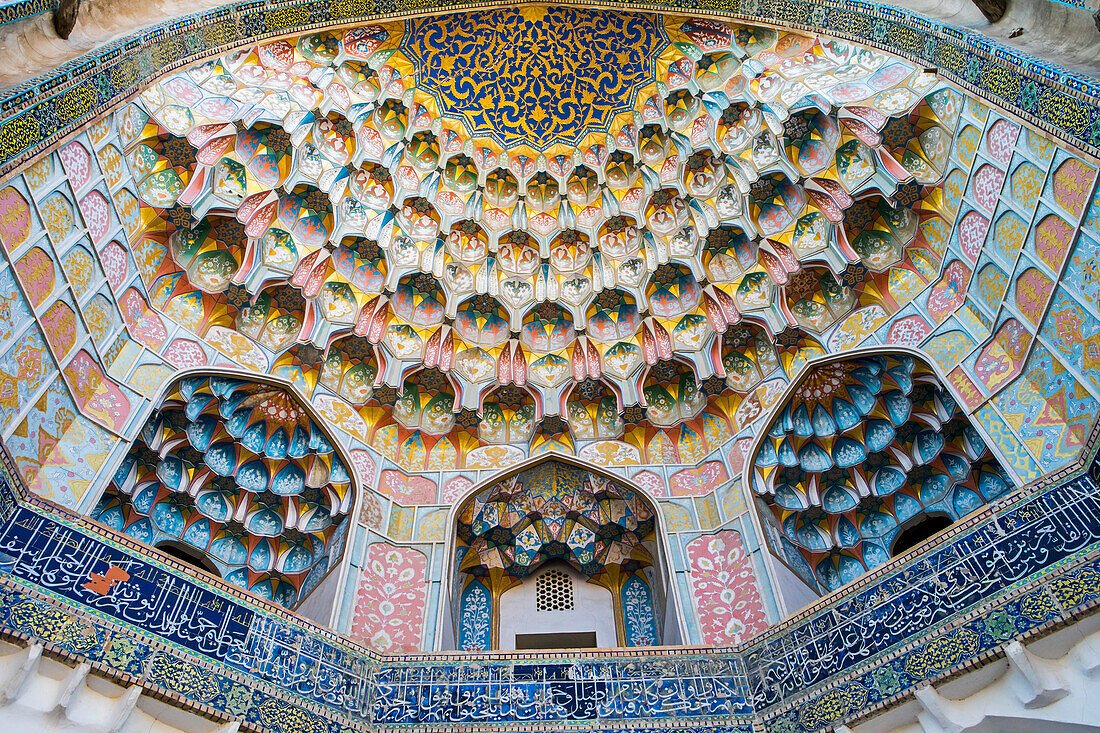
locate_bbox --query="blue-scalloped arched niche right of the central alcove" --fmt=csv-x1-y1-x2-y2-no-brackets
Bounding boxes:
745,349,1013,609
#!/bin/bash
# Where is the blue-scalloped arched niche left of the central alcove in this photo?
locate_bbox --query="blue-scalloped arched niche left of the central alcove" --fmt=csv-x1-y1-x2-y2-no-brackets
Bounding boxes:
90,370,359,608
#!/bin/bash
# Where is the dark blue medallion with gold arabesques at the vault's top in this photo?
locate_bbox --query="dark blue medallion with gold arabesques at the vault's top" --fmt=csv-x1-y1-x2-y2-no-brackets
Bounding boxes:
402,6,669,151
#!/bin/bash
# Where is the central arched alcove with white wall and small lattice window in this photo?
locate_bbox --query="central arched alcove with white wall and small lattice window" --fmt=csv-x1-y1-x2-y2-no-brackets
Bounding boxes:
440,453,681,652
